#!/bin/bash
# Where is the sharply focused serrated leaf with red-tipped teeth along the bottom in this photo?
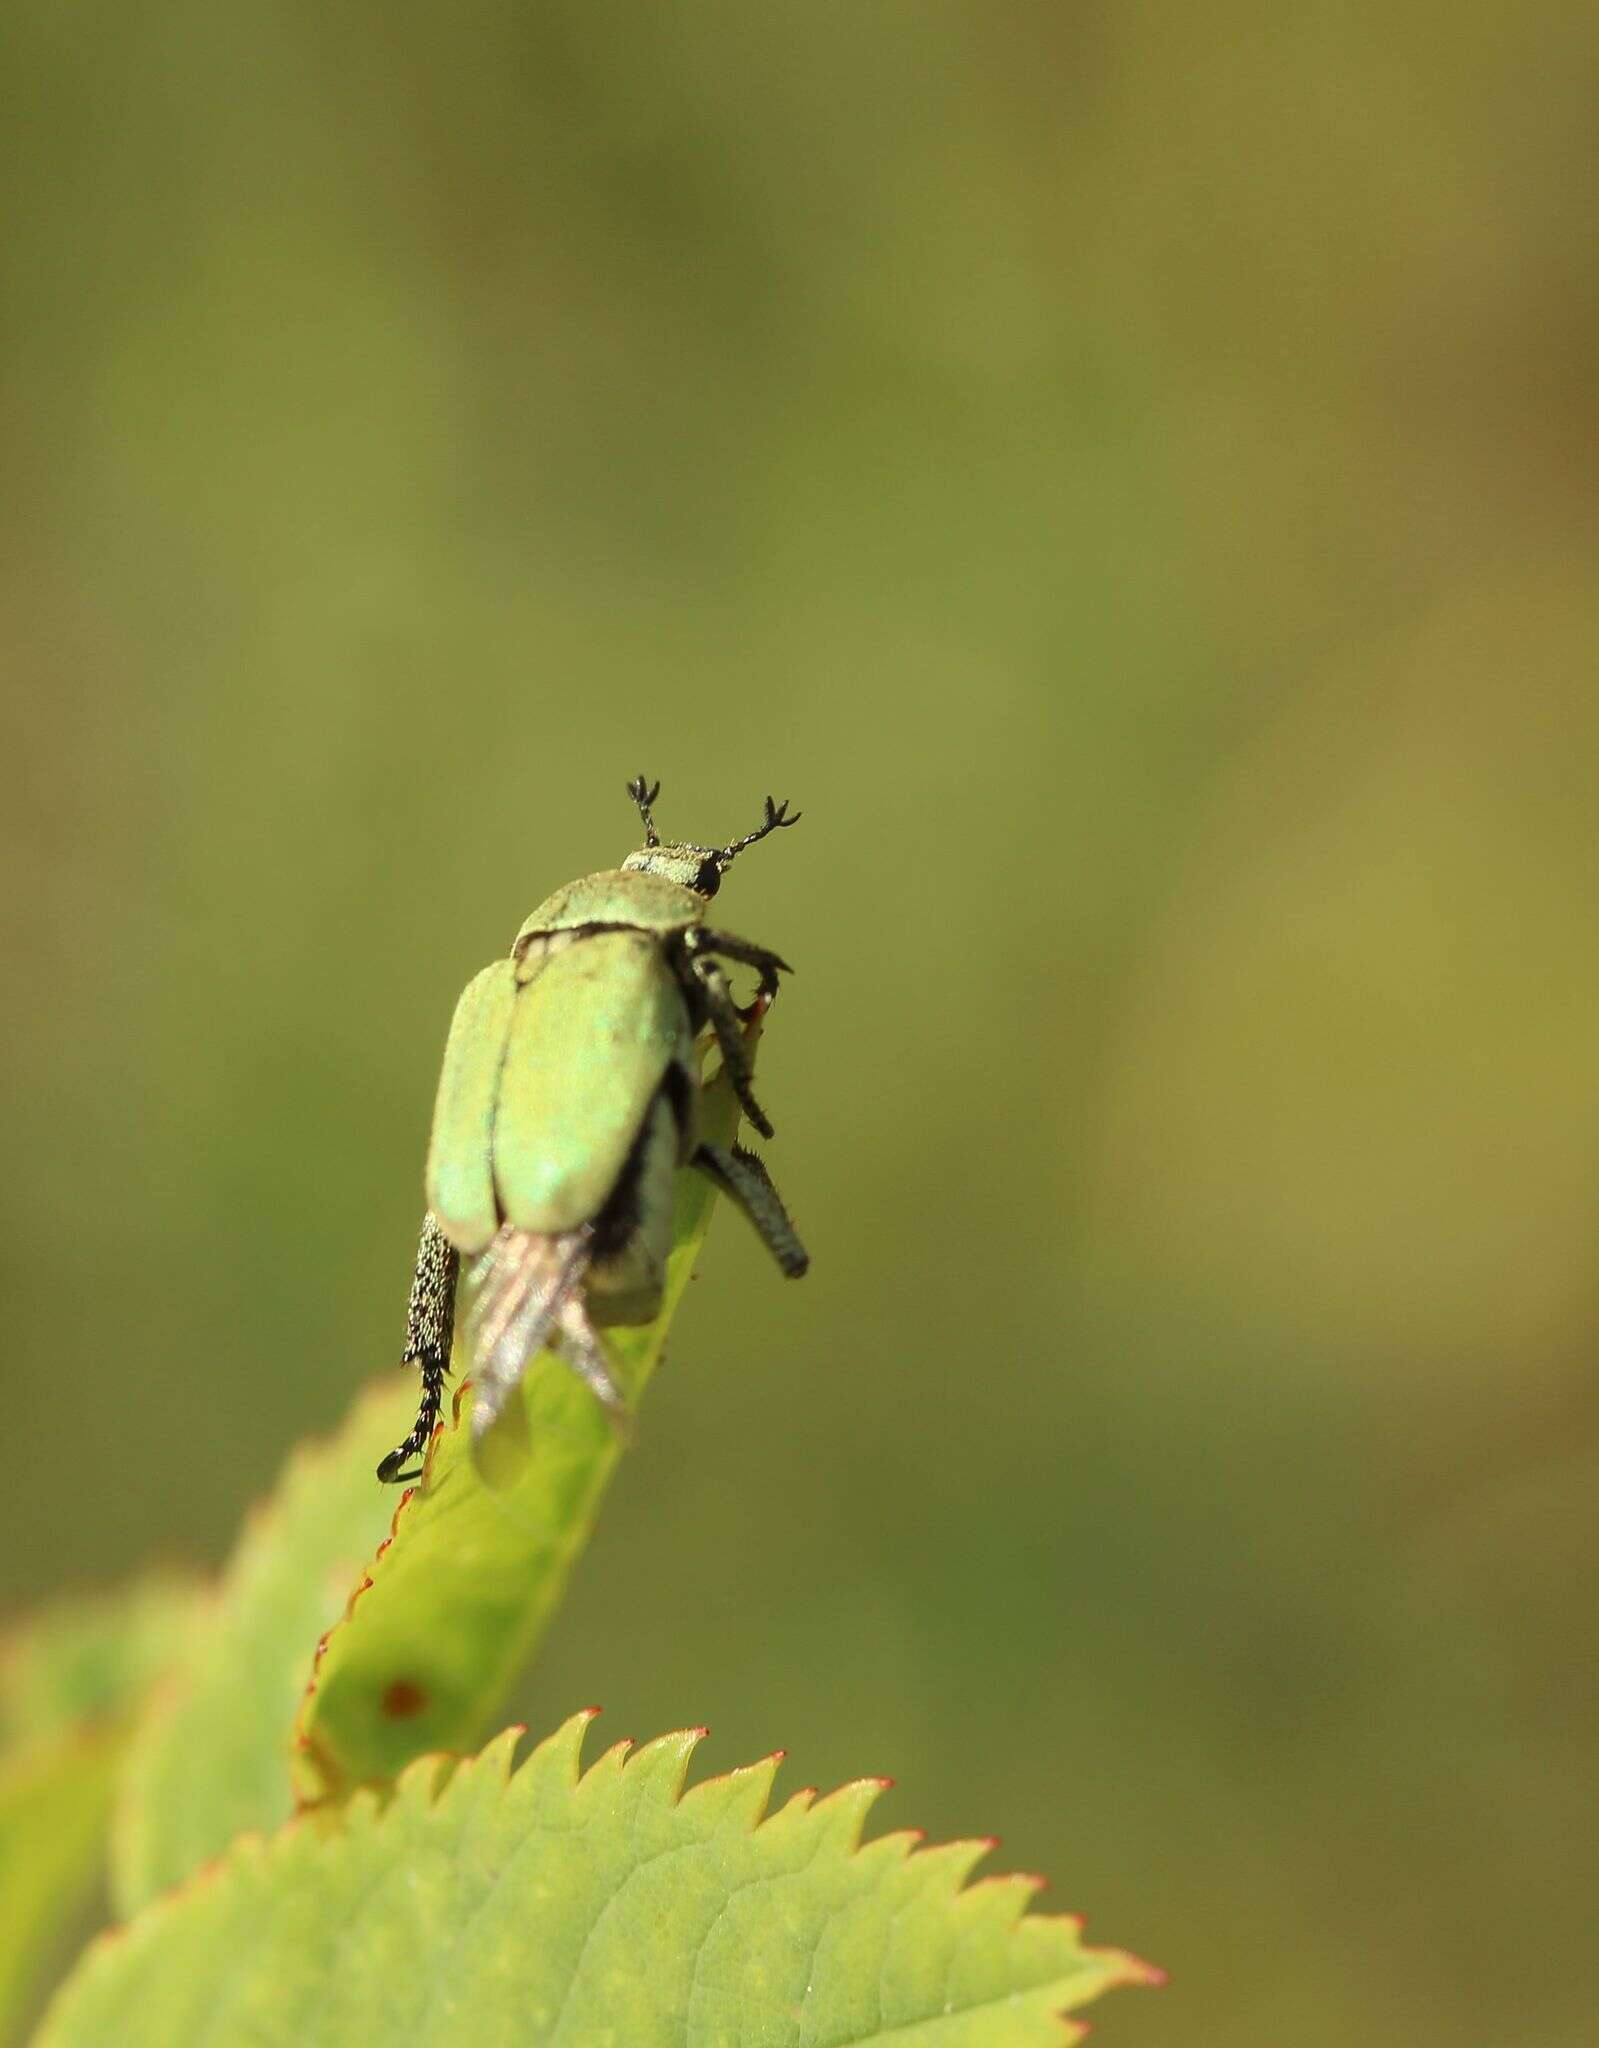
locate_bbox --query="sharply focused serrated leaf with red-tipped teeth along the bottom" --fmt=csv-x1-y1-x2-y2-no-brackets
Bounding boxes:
35,1714,1155,2048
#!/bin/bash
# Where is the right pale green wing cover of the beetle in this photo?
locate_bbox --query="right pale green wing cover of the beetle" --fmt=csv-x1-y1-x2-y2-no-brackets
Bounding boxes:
491,932,692,1233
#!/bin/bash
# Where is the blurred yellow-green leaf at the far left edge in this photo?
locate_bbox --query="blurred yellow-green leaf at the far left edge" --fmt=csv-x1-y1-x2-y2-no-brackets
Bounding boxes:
0,1579,197,2042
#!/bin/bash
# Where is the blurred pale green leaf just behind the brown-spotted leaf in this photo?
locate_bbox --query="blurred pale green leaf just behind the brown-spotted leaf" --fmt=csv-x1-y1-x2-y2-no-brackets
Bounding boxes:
111,1372,416,1913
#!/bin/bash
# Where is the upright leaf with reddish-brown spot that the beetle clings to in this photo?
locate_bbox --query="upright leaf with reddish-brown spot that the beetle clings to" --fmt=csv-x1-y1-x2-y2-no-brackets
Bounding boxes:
295,1079,739,1800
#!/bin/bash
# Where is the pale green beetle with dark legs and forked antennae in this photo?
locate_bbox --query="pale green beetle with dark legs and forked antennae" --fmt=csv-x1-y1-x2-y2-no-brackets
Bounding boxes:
377,776,809,1481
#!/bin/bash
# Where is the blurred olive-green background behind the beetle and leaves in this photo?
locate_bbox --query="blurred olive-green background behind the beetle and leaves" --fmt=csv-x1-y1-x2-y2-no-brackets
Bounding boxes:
0,0,1599,2048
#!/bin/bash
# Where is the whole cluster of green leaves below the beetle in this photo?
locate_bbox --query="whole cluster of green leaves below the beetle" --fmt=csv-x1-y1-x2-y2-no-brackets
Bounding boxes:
12,1079,1153,2048
